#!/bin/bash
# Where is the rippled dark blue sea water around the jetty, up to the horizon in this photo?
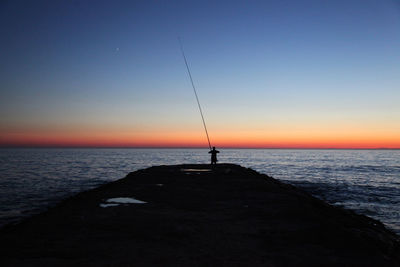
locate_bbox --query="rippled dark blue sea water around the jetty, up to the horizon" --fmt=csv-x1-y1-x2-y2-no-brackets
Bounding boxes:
0,148,400,234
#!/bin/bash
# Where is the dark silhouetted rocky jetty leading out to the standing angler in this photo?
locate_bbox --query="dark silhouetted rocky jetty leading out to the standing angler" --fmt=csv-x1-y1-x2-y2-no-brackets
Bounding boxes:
0,164,400,266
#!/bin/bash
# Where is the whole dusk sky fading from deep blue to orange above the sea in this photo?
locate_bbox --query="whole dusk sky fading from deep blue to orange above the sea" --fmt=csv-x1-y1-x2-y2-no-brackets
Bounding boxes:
0,0,400,148
